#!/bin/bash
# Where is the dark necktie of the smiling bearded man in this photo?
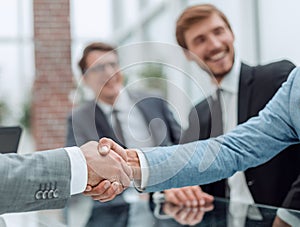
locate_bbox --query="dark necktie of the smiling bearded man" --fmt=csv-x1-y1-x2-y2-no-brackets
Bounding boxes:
210,89,223,137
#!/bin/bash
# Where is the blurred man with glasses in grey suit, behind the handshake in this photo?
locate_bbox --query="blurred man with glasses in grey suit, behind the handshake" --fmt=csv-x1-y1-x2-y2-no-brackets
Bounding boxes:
67,43,181,226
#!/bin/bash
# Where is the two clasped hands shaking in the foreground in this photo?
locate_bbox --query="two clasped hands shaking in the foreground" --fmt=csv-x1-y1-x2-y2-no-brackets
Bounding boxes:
80,138,141,202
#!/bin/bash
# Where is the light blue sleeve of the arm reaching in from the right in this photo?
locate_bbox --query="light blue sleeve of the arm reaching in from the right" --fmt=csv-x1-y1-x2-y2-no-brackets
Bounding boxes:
141,68,300,192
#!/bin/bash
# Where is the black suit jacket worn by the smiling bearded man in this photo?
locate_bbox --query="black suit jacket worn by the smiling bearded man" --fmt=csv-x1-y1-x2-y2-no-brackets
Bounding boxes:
181,61,300,209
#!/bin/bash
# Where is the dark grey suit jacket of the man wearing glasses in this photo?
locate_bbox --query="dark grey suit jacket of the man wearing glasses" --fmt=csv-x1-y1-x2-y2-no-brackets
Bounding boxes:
67,93,181,227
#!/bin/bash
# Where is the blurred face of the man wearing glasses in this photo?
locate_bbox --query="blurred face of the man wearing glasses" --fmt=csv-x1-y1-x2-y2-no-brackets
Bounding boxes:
84,50,123,104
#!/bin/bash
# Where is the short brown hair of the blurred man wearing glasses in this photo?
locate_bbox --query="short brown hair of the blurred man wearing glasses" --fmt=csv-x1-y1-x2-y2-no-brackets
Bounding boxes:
78,42,118,74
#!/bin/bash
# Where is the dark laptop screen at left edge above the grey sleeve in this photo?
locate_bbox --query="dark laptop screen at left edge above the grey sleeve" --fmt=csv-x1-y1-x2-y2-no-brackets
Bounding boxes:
0,126,22,154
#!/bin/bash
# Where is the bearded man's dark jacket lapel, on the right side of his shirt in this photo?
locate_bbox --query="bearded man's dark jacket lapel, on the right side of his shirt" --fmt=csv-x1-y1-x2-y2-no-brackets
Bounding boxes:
238,63,254,124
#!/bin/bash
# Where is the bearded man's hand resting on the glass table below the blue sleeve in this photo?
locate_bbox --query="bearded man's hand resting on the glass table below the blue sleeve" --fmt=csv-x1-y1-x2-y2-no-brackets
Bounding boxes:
164,186,214,207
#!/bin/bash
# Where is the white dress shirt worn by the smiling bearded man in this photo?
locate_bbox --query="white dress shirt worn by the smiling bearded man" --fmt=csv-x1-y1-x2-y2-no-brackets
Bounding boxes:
213,58,262,227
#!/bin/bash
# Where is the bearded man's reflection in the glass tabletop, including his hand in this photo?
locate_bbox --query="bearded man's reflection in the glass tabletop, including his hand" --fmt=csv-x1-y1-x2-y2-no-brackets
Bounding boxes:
154,198,300,227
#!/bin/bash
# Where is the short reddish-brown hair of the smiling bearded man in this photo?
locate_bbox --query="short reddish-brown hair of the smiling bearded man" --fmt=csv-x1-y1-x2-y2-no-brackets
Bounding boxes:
176,4,232,49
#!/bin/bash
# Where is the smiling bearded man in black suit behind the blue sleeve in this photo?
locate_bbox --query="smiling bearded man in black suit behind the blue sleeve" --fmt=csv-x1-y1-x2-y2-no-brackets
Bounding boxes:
154,4,300,218
